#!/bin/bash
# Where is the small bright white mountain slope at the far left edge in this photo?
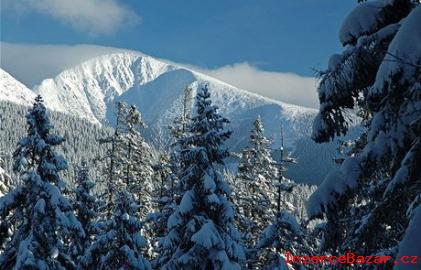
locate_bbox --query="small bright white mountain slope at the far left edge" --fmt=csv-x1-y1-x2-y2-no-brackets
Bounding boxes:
0,68,35,105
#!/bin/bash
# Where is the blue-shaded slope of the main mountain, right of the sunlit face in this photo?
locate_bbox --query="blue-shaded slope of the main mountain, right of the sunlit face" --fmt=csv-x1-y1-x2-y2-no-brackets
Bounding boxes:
115,69,314,150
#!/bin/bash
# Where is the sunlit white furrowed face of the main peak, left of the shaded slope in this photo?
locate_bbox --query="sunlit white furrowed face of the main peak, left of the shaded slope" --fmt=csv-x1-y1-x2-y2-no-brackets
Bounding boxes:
35,53,176,123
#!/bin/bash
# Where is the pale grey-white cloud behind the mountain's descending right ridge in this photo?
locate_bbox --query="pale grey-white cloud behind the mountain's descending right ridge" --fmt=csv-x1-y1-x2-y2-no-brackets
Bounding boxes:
195,63,319,108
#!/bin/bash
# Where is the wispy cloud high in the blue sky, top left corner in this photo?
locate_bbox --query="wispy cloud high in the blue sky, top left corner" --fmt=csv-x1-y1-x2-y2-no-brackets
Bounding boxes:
2,0,140,35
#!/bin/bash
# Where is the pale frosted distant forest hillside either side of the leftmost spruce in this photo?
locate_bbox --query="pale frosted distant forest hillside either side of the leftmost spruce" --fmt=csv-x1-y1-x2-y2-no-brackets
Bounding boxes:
0,100,111,185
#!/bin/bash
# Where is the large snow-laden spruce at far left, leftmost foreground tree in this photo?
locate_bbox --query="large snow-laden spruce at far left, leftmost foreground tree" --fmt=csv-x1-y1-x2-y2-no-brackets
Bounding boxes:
0,96,84,269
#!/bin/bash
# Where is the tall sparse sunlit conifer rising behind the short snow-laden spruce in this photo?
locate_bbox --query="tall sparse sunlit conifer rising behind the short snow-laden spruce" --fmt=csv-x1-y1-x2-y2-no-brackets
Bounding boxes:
99,102,154,218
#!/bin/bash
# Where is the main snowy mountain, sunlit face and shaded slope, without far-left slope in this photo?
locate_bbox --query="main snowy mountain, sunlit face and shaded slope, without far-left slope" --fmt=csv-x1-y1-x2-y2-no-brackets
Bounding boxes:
34,52,316,148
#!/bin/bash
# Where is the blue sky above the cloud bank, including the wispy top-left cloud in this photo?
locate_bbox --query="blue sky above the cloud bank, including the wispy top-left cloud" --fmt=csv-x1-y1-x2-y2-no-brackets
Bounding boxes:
1,0,357,107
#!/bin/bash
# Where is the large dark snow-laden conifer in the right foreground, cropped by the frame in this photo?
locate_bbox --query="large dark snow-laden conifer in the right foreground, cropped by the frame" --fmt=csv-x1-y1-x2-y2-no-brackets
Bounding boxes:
308,0,421,267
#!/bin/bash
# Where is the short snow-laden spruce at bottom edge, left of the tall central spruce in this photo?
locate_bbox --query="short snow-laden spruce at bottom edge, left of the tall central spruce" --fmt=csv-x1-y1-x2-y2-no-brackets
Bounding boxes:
80,191,152,270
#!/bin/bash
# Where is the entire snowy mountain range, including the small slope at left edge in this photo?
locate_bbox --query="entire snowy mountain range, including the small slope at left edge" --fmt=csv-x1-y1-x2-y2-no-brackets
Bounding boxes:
0,53,342,184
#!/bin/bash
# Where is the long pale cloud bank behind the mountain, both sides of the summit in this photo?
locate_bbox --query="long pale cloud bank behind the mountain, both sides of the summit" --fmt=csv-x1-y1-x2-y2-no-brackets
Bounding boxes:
0,42,319,108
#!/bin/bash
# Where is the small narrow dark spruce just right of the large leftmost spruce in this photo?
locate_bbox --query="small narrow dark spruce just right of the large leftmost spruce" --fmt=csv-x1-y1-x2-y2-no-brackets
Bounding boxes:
71,161,101,260
